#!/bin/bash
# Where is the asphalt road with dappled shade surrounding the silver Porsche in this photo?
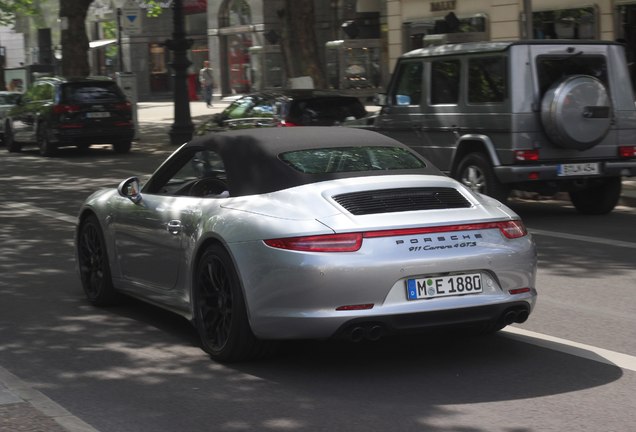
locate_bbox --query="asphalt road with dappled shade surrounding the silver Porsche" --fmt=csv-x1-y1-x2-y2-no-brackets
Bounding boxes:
0,103,636,432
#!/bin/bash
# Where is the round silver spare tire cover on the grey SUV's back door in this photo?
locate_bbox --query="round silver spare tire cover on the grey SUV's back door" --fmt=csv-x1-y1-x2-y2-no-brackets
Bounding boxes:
541,75,612,150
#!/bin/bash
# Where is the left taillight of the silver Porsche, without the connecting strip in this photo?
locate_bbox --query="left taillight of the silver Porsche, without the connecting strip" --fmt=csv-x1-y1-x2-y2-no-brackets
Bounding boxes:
265,233,362,252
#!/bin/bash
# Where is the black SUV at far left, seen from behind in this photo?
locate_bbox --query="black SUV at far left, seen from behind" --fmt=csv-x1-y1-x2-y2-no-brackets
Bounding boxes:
4,77,135,156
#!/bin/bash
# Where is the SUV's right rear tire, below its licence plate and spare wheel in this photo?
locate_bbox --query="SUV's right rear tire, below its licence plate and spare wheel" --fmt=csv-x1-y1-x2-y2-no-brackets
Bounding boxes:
570,177,623,215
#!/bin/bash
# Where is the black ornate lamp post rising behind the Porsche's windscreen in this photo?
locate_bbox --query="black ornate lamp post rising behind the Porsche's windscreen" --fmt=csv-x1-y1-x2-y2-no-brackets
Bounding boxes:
165,0,194,145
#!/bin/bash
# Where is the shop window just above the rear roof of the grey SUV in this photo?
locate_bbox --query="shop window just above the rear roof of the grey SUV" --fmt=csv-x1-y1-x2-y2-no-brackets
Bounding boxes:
532,7,598,39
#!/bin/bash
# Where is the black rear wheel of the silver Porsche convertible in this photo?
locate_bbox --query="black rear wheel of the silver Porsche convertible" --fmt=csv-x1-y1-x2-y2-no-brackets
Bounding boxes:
193,245,267,363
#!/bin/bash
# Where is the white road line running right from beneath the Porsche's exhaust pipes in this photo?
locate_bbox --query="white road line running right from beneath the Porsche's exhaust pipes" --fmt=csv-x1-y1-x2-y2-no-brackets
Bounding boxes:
501,326,636,372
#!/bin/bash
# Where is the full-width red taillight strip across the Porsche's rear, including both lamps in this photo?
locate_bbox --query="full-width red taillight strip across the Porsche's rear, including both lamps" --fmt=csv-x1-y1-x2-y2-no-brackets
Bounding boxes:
264,220,528,252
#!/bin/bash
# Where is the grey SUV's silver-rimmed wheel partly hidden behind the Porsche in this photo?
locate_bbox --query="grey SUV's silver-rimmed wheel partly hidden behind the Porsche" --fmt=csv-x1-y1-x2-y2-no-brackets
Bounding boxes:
455,153,510,203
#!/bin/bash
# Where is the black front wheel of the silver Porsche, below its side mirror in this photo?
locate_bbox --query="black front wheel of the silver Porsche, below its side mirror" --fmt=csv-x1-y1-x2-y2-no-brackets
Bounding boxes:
77,215,121,306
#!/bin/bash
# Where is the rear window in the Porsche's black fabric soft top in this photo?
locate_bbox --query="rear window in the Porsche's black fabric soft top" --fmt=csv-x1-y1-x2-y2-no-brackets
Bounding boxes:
279,147,426,174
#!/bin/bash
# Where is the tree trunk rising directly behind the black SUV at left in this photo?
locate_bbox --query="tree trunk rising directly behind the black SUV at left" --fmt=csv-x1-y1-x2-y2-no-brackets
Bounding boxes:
60,0,93,77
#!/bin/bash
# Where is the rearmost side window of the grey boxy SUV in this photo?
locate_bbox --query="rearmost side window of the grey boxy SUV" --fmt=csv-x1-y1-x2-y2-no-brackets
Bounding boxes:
468,56,508,104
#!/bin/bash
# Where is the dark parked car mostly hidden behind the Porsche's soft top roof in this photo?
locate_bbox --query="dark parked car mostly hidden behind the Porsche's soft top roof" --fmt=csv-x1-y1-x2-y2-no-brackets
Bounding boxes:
196,90,367,135
